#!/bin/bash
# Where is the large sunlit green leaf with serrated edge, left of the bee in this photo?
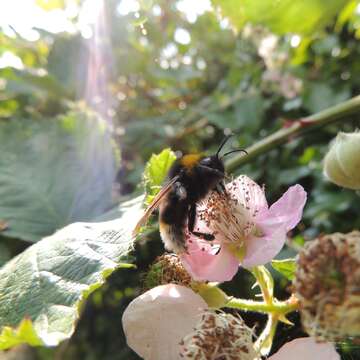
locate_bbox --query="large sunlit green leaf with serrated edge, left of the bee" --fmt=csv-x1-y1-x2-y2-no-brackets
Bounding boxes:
0,197,142,346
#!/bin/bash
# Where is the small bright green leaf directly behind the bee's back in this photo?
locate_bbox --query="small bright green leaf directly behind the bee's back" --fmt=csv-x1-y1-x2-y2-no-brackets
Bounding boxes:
144,149,176,203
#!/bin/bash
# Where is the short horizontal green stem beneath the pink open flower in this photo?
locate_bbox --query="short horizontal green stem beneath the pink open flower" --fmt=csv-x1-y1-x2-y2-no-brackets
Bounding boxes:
225,298,299,315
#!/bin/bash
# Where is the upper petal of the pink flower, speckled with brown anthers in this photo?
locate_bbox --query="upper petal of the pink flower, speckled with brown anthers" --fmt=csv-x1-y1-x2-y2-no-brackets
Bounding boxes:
226,175,268,214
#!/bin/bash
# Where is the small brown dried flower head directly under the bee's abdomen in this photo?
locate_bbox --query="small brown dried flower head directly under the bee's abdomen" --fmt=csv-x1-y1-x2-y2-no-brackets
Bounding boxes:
144,254,192,290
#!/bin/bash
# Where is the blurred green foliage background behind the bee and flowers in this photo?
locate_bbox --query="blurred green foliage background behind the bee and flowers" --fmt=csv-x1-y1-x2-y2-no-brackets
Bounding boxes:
0,0,360,359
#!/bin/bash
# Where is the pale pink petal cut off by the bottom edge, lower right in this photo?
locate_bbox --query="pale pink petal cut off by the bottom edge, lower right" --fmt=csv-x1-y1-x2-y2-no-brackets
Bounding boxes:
269,337,340,360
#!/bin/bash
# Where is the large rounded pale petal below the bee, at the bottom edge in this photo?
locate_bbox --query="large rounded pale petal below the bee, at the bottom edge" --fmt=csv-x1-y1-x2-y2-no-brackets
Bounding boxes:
122,284,208,360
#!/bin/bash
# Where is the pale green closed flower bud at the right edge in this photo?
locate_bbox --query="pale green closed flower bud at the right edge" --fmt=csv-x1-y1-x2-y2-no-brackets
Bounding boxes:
324,132,360,190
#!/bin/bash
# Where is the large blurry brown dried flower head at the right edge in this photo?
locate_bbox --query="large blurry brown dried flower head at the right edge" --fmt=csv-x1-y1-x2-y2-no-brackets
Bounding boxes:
294,231,360,341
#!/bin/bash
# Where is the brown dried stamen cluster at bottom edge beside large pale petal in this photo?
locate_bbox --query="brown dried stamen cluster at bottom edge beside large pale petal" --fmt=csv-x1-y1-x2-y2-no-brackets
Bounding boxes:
180,310,257,360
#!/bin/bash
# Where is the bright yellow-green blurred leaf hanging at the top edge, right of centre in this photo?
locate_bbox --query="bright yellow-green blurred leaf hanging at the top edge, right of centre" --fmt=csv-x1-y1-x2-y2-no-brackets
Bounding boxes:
212,0,348,34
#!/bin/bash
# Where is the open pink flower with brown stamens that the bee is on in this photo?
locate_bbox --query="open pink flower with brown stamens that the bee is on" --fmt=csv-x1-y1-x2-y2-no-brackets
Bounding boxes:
180,175,306,281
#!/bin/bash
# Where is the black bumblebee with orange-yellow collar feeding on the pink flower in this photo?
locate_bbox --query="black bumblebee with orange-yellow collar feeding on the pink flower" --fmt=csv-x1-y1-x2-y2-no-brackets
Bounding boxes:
133,135,247,253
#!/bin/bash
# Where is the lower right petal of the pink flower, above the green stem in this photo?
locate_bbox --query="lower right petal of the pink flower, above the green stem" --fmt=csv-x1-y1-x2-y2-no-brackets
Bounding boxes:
241,225,286,268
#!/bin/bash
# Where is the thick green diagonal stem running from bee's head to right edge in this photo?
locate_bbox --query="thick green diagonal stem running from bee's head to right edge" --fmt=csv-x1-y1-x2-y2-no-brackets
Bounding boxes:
225,95,360,172
